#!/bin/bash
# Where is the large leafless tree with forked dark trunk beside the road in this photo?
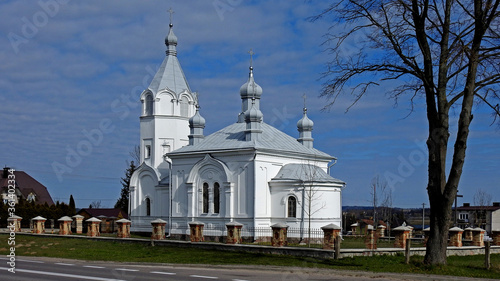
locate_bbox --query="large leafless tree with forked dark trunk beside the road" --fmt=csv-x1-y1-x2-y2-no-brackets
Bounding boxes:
312,0,500,264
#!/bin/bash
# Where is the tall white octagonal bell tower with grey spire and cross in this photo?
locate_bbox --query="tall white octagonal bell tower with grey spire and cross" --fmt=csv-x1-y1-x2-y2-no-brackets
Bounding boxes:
140,10,197,168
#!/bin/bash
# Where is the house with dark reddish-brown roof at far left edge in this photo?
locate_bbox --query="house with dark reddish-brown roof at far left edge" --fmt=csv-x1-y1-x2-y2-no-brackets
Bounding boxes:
0,167,54,205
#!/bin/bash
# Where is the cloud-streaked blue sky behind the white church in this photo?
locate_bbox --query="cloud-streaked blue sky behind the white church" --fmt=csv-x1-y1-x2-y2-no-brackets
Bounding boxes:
0,0,500,207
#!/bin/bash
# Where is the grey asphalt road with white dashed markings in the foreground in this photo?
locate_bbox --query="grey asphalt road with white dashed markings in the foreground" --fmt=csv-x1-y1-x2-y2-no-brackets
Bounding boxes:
0,257,492,281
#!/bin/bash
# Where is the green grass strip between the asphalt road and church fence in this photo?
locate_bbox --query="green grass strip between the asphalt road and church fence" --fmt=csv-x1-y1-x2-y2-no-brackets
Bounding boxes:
0,234,500,279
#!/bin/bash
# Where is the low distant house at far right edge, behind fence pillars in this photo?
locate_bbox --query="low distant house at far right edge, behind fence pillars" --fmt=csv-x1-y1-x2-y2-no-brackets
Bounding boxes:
457,202,500,233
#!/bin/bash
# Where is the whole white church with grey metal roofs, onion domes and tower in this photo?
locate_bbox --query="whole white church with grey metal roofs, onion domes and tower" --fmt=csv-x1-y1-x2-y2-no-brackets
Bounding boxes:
129,20,345,234
